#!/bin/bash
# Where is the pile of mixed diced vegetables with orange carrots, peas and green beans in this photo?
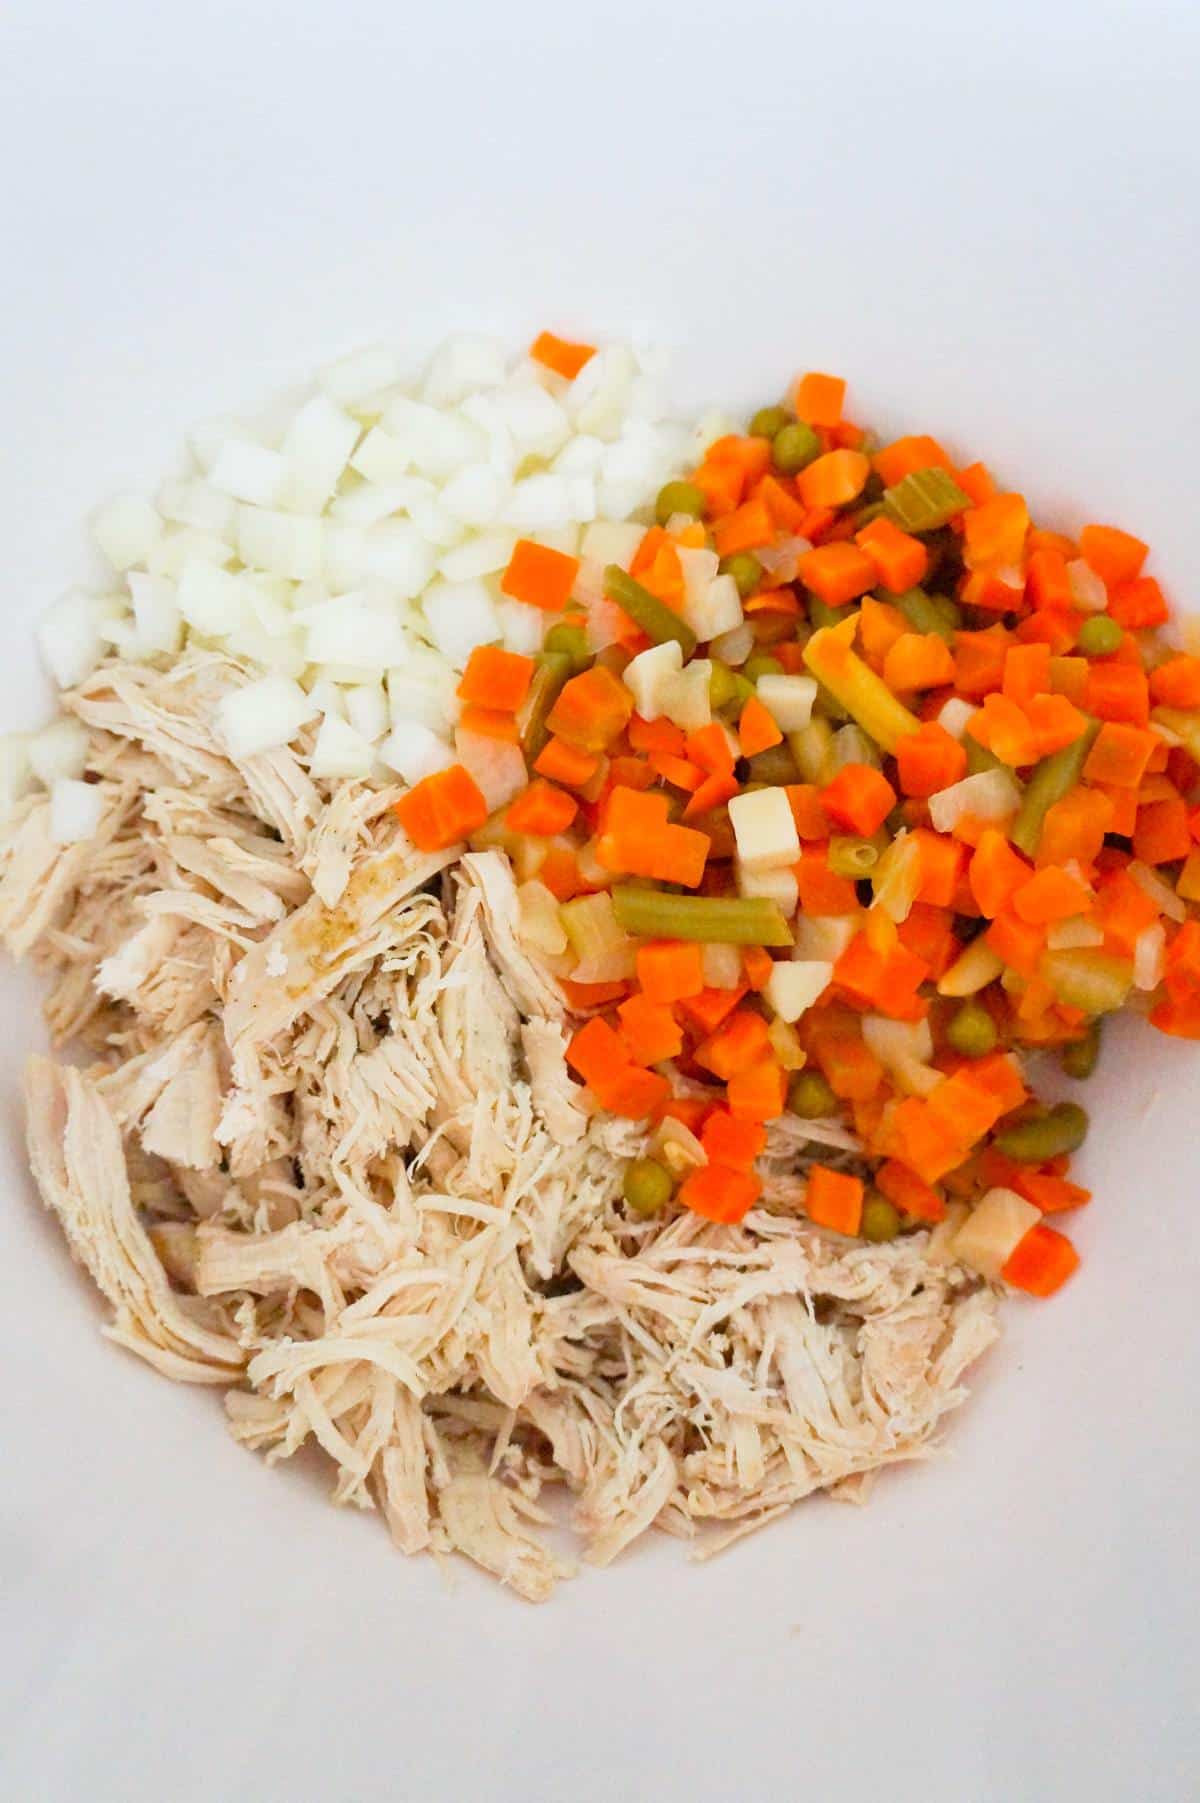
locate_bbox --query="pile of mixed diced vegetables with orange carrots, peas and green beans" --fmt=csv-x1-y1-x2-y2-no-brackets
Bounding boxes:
396,335,1200,1295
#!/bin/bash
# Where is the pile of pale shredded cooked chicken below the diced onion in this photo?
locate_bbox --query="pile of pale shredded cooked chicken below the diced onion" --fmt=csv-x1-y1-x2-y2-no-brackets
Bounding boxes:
0,653,996,1599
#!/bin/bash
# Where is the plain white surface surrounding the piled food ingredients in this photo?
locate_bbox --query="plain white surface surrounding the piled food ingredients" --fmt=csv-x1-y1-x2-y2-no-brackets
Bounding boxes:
0,0,1200,1803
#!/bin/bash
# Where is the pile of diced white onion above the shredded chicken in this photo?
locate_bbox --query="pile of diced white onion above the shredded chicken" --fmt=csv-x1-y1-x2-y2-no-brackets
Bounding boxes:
9,335,728,842
